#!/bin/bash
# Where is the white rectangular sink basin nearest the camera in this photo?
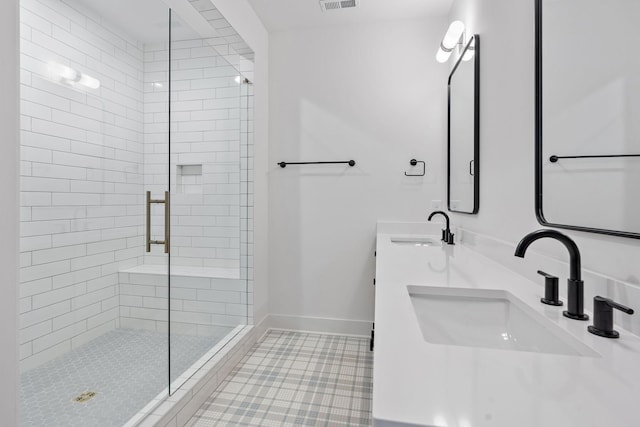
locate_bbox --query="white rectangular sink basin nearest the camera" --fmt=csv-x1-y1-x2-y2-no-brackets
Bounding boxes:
407,286,599,357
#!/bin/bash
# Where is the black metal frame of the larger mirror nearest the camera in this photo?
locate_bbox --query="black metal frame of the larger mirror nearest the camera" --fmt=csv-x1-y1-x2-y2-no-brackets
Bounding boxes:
534,0,640,239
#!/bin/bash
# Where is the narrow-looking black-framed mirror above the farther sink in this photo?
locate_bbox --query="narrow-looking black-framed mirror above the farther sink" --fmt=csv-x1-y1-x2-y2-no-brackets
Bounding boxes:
447,35,480,214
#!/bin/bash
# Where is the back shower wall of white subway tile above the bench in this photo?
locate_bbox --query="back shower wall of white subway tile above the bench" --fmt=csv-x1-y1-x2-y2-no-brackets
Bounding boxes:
144,39,242,269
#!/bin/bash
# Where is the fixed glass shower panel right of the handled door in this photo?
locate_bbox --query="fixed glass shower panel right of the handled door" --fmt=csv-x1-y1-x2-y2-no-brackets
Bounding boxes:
169,13,247,392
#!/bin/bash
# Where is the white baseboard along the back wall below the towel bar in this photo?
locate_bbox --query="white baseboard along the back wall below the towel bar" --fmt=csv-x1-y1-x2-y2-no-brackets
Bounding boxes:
265,314,373,337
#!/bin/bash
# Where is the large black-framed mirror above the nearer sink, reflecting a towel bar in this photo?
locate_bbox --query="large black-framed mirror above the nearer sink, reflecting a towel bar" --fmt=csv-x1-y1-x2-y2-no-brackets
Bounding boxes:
535,0,640,239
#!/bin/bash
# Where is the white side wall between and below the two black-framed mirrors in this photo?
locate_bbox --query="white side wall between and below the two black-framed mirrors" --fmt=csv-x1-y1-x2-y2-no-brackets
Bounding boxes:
450,0,640,286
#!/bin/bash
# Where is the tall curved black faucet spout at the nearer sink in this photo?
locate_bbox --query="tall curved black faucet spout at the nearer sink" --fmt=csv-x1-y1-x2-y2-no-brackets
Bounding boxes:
514,230,589,320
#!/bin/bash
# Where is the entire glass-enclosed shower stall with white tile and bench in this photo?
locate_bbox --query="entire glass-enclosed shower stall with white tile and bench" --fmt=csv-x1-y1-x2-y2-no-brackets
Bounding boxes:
20,0,253,427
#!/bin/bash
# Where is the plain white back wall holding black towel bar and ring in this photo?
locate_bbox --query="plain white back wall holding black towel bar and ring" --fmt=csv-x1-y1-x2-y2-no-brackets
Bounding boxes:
269,17,448,334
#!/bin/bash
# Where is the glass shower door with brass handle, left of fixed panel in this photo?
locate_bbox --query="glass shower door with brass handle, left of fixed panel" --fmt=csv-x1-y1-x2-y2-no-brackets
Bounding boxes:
20,0,169,426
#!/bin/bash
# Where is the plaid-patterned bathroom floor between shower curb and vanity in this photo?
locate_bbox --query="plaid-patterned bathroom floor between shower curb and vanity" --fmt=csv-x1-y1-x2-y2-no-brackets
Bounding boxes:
187,331,373,427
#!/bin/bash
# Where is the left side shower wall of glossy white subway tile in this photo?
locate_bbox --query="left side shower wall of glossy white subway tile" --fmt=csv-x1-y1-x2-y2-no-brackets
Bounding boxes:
20,0,144,369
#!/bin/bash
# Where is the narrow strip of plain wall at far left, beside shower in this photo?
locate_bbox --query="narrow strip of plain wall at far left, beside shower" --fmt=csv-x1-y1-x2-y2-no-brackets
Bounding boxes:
0,0,20,426
